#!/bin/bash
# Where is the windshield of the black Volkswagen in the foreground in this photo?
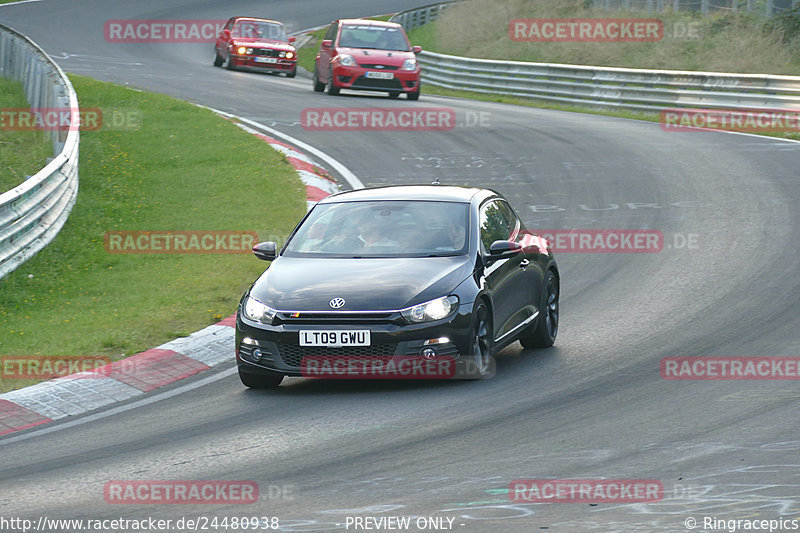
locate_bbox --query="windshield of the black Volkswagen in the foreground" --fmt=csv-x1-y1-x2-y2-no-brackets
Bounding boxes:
284,200,469,257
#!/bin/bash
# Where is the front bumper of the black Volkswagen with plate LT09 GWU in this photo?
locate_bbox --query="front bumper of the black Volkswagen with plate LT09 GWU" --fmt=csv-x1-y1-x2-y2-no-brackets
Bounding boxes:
236,303,472,376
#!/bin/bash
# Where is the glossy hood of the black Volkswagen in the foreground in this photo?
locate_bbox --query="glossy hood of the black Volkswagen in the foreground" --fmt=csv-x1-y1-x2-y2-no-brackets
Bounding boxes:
250,256,473,311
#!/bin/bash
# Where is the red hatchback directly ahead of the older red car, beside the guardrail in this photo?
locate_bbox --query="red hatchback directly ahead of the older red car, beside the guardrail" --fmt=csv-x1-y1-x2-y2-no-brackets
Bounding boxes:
314,19,422,100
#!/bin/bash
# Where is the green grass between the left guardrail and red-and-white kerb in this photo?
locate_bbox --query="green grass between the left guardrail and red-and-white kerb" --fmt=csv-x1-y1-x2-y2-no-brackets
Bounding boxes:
0,76,305,392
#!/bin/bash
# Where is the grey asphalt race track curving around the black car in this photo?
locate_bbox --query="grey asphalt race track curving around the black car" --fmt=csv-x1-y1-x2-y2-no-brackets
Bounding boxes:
0,0,800,532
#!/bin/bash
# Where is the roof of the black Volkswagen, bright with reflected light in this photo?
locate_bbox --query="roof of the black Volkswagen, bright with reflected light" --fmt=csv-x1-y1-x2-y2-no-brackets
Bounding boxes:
319,185,497,204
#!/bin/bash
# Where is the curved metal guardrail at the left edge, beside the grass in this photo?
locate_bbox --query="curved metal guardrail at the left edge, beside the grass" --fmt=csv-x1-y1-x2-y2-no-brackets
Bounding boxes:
0,24,80,278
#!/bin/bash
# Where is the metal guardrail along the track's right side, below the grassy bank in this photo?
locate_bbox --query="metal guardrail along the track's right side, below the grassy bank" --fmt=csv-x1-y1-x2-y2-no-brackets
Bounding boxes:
392,2,800,112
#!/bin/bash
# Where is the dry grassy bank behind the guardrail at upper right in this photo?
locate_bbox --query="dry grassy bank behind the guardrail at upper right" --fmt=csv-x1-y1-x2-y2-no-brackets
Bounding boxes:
416,0,800,75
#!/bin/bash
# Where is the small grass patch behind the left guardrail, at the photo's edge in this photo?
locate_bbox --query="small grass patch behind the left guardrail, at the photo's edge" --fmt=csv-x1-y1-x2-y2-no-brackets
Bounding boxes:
0,78,53,194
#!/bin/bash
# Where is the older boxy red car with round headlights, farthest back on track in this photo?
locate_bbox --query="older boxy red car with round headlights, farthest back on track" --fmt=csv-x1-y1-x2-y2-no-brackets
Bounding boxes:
214,17,297,78
